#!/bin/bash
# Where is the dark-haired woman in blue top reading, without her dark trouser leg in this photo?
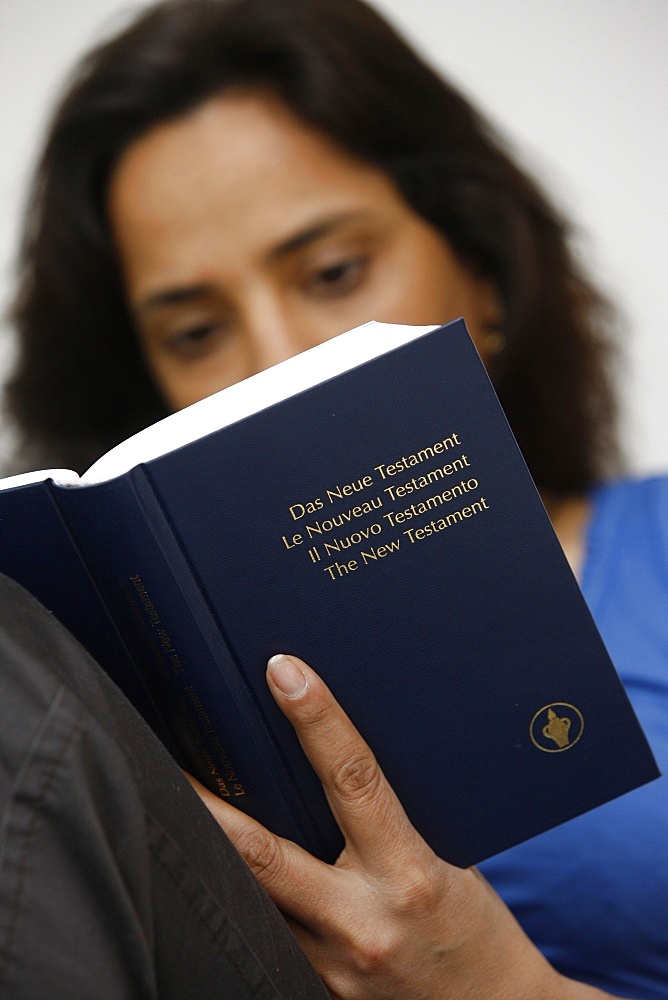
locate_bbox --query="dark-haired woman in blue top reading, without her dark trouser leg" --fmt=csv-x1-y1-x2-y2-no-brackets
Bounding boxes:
2,0,668,998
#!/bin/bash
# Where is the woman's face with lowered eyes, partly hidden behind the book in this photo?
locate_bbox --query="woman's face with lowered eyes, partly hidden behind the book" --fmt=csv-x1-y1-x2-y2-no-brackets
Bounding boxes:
109,95,498,409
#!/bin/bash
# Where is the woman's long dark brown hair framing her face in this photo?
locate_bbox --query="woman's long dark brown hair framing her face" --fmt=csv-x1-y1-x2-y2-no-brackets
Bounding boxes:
6,0,616,495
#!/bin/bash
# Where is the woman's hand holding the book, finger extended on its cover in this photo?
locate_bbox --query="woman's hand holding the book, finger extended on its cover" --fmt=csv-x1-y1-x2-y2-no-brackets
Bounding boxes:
193,656,620,1000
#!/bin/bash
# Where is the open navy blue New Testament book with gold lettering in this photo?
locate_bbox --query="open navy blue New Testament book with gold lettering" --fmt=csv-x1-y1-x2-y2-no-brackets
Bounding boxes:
0,320,658,867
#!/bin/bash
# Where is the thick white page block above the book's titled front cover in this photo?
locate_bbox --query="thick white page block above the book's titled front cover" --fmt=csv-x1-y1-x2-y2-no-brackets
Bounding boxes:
81,322,439,485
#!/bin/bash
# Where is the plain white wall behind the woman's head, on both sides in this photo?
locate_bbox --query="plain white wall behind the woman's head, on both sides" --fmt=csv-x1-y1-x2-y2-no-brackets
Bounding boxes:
0,0,668,471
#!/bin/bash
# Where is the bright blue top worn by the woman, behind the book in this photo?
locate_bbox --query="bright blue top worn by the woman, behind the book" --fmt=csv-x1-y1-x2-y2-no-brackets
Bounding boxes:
480,477,668,1000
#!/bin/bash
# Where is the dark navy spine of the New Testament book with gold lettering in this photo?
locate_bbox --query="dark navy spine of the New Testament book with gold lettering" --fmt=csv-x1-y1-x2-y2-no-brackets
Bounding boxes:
53,467,341,860
